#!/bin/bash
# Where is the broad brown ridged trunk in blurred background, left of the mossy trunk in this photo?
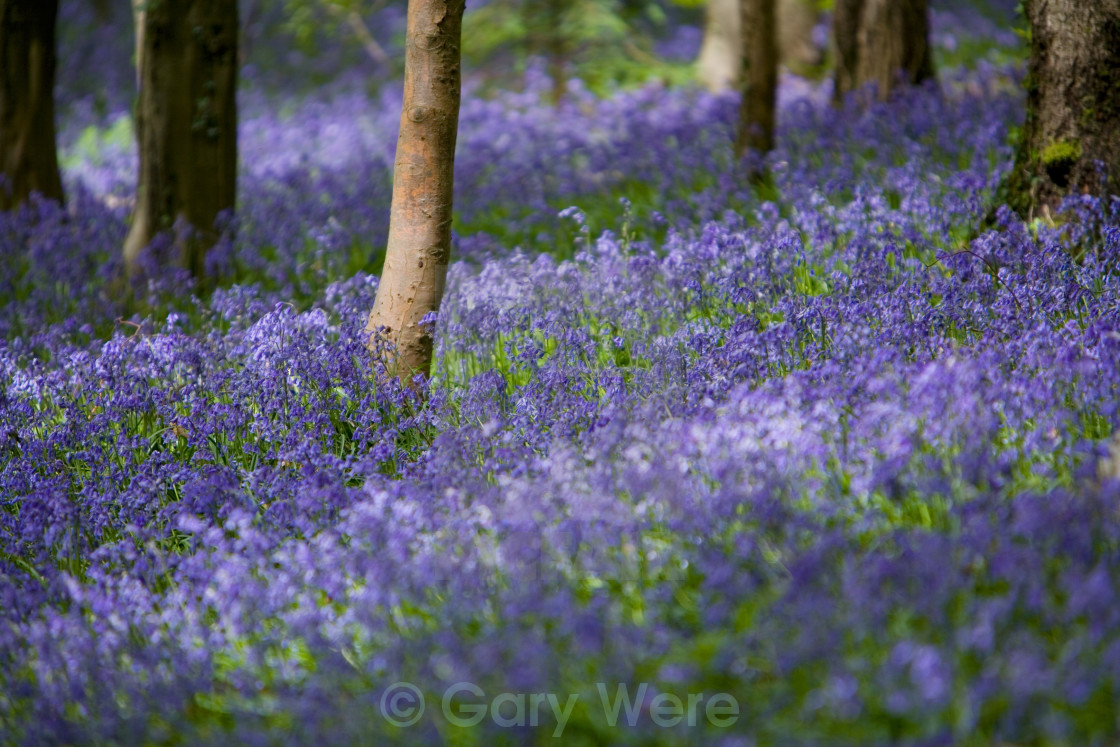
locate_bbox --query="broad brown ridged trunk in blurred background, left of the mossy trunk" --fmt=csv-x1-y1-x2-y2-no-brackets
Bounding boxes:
832,0,934,102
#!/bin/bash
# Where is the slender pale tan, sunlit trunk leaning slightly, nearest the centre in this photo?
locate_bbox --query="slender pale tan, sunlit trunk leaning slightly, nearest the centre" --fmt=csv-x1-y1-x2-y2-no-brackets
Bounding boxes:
366,0,465,382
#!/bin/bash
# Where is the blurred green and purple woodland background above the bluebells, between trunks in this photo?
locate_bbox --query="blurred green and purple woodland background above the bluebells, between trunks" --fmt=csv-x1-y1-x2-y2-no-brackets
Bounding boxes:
58,0,1023,119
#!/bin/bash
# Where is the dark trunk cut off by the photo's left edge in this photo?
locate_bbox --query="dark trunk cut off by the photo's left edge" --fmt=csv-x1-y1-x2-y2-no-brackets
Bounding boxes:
0,0,63,211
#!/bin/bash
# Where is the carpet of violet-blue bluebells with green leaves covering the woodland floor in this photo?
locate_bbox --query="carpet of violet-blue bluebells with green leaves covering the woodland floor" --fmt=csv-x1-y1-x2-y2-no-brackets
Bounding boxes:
0,5,1120,747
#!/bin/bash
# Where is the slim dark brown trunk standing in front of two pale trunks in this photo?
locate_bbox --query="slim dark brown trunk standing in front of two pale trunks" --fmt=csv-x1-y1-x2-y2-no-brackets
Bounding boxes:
735,0,777,157
